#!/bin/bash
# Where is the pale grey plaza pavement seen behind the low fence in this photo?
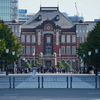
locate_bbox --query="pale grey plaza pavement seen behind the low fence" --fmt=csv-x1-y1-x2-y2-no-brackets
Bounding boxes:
0,73,100,89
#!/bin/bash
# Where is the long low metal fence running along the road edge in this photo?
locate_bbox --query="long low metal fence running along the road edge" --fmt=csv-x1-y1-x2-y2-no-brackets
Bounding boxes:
0,75,100,89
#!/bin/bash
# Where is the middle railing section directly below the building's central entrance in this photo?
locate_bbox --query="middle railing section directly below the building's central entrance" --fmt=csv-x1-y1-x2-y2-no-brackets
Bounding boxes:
42,76,68,88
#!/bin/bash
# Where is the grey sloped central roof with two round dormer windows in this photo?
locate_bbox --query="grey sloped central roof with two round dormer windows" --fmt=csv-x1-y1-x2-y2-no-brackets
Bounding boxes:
22,7,74,28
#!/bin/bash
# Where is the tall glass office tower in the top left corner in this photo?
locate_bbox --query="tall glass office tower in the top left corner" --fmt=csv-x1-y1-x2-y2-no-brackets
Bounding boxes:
0,0,18,21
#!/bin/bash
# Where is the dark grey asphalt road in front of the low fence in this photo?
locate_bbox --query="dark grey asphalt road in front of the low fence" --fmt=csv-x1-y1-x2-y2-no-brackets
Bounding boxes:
0,89,100,100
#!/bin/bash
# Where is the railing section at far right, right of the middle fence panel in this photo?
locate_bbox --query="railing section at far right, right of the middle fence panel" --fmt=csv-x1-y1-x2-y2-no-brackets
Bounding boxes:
70,76,100,88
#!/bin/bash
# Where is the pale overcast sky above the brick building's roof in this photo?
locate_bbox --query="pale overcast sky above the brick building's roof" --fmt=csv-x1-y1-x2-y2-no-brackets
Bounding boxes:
19,0,100,21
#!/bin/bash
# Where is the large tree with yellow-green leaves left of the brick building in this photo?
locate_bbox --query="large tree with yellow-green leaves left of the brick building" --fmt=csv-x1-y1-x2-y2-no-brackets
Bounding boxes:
0,20,22,64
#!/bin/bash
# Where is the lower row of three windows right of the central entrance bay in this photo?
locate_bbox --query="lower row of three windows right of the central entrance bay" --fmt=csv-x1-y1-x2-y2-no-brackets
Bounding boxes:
61,46,76,55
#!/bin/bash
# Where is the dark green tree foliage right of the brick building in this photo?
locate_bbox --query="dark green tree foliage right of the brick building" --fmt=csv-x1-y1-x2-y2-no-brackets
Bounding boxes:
78,22,100,65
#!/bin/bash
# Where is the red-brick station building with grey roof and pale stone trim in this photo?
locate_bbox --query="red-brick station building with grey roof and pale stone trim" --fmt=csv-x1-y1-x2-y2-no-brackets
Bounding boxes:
7,7,95,69
